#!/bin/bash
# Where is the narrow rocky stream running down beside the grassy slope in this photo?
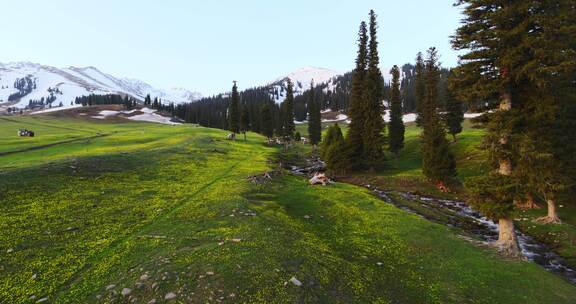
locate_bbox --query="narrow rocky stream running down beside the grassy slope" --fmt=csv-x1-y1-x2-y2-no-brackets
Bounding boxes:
289,160,576,285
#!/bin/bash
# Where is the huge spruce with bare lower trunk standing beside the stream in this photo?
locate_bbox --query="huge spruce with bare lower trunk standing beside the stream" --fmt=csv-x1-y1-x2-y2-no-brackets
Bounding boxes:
452,0,539,255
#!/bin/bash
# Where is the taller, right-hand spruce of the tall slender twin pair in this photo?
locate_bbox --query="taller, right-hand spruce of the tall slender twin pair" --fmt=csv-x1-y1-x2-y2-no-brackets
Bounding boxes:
363,10,386,170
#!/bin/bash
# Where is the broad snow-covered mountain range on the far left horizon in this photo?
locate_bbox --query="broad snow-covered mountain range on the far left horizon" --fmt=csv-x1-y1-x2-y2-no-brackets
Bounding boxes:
0,62,201,108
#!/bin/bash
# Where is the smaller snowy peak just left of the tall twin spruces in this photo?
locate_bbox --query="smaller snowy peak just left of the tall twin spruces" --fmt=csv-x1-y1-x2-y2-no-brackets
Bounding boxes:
268,66,344,103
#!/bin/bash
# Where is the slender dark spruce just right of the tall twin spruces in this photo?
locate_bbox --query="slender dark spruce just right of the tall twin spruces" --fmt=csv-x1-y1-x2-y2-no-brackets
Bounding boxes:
388,65,405,154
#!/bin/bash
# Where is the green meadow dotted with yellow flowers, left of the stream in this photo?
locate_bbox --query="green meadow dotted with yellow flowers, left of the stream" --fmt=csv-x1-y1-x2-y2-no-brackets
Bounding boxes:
0,116,576,303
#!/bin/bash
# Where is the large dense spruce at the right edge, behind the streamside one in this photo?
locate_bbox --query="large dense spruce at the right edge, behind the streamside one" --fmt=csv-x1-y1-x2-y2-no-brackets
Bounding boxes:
515,0,576,223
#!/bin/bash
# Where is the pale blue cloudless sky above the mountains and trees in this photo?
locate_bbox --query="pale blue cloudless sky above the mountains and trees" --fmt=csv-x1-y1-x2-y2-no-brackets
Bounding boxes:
0,0,460,95
